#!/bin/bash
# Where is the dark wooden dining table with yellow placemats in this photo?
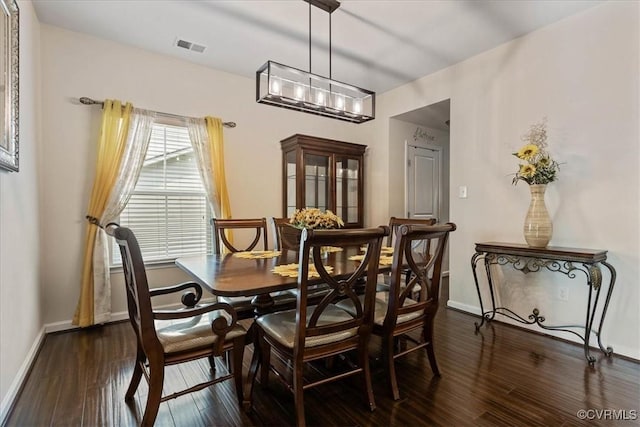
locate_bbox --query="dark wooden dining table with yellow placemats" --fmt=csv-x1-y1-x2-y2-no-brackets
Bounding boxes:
175,246,392,410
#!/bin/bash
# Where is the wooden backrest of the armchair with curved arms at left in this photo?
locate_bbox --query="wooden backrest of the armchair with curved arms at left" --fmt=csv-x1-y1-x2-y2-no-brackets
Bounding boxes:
112,227,163,354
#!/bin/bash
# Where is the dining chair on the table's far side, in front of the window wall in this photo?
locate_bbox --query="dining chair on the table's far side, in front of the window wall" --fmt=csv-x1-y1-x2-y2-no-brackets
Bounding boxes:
211,218,295,319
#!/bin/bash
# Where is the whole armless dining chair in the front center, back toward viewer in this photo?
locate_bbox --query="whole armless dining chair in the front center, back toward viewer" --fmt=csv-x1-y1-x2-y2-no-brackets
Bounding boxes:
249,226,389,426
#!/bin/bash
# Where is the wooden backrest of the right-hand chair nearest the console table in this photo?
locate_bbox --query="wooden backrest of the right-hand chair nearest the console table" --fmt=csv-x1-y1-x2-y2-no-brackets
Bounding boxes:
384,223,456,328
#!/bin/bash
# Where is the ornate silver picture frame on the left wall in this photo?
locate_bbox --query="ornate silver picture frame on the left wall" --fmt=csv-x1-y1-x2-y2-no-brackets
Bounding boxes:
0,0,20,172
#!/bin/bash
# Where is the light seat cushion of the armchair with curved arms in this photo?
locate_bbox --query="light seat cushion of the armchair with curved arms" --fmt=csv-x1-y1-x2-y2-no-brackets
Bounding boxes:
155,310,247,353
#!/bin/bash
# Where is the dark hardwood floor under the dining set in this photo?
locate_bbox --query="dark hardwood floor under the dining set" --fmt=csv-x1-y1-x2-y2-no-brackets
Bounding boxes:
7,280,640,427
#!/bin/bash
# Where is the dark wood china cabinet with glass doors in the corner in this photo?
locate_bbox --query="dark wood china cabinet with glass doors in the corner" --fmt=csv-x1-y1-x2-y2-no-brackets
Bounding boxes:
280,134,367,228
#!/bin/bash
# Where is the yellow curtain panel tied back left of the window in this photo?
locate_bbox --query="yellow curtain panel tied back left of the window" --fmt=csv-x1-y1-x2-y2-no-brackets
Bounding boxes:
73,100,133,326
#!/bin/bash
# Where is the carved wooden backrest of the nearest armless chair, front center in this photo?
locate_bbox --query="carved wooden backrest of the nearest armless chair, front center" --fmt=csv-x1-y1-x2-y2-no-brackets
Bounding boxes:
294,226,389,348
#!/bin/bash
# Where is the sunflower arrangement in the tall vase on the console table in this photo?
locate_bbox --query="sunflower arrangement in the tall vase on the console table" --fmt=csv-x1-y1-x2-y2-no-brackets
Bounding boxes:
513,119,560,185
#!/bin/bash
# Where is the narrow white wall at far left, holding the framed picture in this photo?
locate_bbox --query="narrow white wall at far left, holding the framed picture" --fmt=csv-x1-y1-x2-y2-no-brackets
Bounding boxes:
0,1,43,416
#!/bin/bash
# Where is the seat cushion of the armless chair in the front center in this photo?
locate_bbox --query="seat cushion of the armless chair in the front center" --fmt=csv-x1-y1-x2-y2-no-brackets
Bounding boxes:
256,304,358,348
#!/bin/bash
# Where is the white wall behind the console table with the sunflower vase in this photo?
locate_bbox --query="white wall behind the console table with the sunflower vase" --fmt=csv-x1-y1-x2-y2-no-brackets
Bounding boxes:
368,2,640,359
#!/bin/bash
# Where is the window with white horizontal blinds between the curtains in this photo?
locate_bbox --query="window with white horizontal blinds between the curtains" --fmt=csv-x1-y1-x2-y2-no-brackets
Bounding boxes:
112,123,212,265
